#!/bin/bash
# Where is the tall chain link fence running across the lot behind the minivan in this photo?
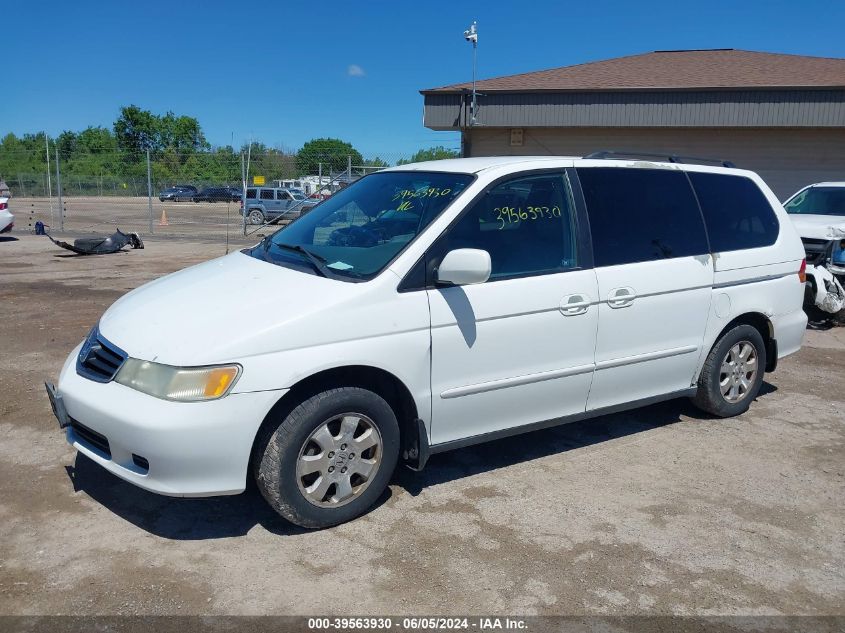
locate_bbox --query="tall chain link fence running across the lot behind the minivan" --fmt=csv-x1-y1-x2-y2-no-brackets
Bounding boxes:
0,147,420,241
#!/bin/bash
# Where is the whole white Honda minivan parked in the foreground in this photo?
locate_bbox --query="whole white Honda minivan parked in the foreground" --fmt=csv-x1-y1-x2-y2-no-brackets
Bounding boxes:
47,157,807,528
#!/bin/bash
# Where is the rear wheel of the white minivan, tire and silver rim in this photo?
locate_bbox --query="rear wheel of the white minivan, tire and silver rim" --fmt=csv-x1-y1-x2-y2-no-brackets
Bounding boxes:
692,325,766,418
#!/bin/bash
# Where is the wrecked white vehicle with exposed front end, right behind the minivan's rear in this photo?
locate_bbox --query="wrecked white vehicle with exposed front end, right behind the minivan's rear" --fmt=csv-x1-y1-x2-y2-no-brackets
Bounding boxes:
784,182,845,314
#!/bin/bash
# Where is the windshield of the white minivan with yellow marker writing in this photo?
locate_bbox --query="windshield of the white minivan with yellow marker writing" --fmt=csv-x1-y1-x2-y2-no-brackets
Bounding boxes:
248,171,473,281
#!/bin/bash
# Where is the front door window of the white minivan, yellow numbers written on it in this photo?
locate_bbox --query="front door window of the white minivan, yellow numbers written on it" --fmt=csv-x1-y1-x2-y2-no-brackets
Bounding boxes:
433,173,578,279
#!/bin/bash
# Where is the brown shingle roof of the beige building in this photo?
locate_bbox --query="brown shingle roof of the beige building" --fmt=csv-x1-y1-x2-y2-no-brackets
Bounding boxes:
421,49,845,94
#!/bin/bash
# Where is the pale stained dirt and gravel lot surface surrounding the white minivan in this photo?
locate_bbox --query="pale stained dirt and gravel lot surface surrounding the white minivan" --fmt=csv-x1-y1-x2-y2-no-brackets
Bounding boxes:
0,232,845,615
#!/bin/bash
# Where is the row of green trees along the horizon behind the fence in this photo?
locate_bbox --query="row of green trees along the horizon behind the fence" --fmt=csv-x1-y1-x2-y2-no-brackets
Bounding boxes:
0,105,458,195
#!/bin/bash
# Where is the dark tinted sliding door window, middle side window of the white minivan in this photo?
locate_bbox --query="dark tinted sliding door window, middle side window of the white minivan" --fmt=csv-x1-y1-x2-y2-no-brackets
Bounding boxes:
578,167,708,266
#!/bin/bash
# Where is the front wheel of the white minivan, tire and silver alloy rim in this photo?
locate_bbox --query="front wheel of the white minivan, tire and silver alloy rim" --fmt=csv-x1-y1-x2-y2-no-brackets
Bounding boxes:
252,387,399,528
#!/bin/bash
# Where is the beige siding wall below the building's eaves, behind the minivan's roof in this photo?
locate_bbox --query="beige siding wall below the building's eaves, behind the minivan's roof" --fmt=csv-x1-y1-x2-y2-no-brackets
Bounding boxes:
464,127,845,200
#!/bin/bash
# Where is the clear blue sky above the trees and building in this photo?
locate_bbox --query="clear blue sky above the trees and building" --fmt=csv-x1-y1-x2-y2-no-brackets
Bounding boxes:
0,0,845,159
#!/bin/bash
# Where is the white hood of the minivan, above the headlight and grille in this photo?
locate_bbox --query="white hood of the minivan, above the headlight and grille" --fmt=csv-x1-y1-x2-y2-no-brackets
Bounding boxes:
100,252,361,366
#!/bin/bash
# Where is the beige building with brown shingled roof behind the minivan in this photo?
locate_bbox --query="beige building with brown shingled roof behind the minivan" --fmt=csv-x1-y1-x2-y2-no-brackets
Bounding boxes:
421,49,845,198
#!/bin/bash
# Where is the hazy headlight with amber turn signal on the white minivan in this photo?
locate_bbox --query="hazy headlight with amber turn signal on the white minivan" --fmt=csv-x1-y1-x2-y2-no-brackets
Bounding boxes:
114,358,241,402
